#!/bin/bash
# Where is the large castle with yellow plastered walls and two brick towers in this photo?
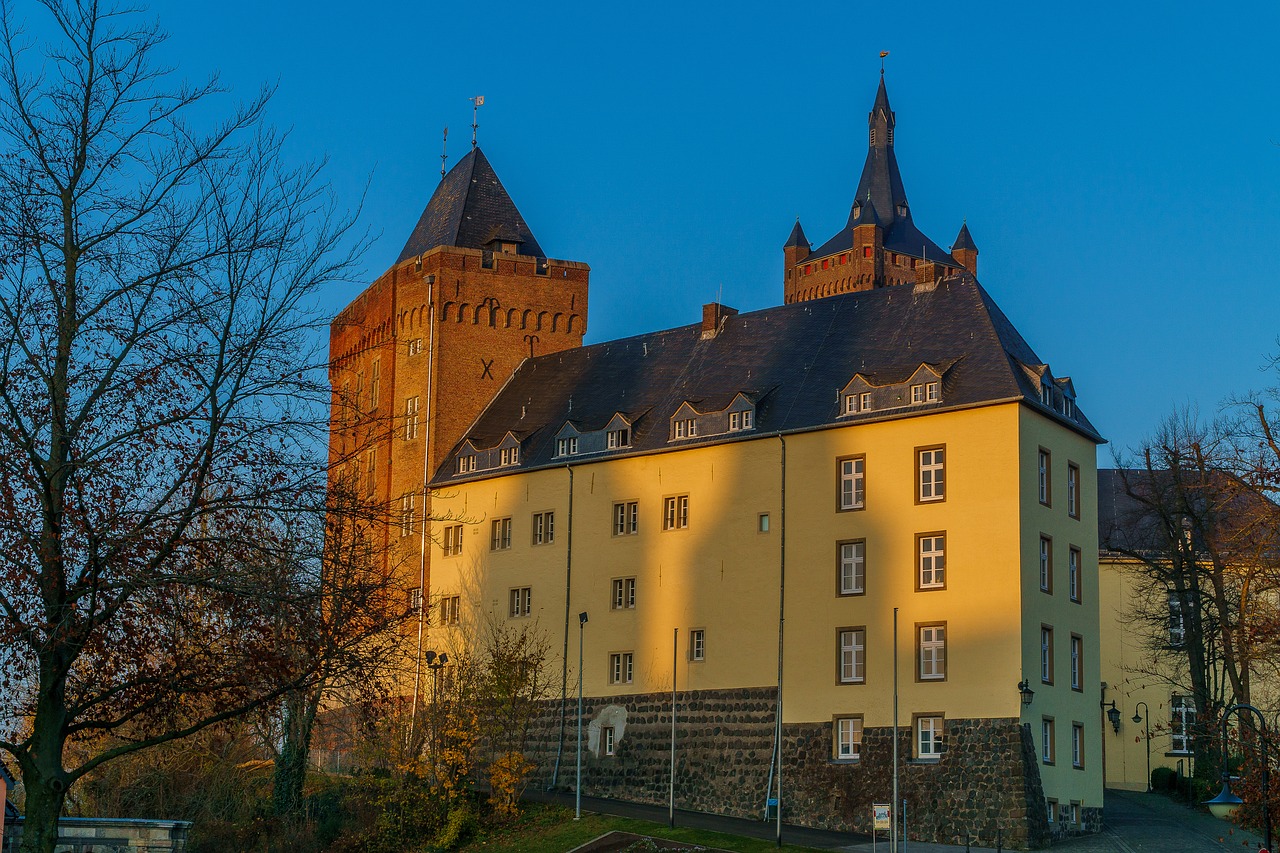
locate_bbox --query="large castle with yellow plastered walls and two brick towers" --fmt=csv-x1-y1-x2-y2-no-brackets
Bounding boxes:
334,79,1102,845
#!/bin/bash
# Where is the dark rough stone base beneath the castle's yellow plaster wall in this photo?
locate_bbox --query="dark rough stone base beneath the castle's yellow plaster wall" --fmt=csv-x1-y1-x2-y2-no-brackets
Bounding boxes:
527,688,1054,848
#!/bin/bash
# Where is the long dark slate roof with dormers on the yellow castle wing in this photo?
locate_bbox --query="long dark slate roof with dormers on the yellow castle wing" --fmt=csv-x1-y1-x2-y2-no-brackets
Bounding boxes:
435,275,1102,480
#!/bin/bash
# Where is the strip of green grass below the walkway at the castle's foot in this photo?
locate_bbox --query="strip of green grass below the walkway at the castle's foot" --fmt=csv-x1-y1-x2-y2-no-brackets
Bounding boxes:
462,804,829,853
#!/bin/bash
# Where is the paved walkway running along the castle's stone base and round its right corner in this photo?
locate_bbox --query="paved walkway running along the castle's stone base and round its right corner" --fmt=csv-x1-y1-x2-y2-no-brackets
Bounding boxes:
525,790,1262,853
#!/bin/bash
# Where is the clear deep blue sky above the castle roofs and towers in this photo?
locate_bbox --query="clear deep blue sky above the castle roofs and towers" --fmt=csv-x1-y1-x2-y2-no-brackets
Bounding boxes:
154,0,1280,464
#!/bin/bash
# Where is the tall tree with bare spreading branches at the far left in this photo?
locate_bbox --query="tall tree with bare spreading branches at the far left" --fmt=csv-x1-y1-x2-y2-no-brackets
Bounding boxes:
0,0,368,853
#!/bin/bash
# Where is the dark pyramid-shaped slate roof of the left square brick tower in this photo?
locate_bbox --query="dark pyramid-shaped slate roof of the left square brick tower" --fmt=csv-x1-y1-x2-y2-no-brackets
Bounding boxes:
396,147,547,264
